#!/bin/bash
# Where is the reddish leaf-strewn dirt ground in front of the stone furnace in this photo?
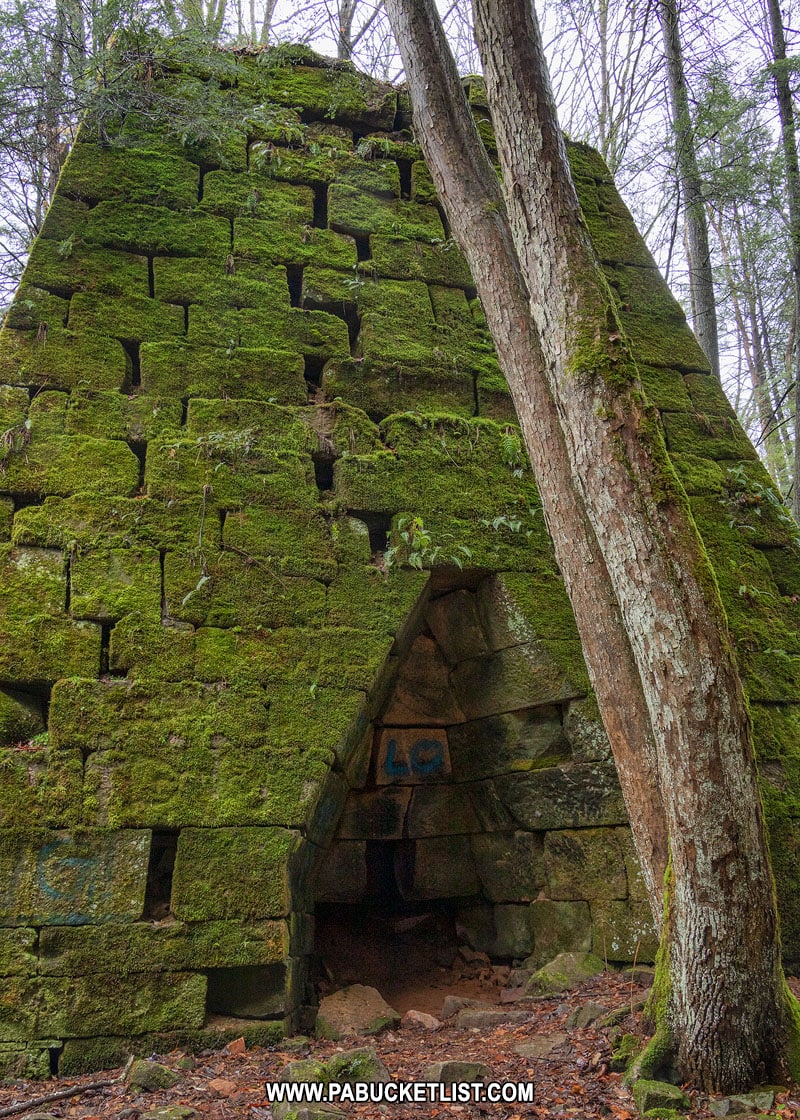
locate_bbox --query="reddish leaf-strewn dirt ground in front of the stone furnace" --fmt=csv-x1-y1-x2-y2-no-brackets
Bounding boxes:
0,961,800,1120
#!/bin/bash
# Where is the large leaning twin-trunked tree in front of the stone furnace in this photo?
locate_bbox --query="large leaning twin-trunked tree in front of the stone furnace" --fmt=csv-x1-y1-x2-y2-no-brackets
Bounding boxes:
388,0,789,1089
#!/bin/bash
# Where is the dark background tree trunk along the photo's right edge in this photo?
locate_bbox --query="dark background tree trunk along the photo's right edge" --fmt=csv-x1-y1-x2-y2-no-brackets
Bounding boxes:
766,0,800,523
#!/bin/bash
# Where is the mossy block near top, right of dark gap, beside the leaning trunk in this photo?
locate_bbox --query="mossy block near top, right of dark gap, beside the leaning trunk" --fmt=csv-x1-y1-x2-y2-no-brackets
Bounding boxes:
328,183,445,242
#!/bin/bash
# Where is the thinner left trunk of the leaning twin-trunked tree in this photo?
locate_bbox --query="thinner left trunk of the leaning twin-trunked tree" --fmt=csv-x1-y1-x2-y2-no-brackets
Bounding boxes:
380,0,667,928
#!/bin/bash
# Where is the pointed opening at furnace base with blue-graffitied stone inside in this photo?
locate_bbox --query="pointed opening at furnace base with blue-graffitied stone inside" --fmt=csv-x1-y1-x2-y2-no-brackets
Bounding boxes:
304,576,626,1014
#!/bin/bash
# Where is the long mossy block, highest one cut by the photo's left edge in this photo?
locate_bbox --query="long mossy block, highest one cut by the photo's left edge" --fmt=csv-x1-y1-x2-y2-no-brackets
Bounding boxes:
0,329,128,389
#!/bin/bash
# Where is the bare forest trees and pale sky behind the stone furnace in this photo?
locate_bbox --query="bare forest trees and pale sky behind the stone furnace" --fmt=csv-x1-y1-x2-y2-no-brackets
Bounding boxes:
0,0,800,520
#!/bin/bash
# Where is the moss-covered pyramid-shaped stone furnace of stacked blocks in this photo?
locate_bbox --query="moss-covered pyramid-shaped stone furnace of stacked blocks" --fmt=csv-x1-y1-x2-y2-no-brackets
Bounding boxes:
0,45,800,1075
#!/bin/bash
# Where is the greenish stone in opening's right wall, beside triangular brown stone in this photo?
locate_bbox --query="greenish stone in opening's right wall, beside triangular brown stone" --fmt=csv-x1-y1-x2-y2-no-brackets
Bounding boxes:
450,642,588,720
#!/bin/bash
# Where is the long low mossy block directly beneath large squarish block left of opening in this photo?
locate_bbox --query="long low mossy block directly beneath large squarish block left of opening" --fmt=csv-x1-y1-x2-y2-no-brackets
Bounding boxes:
39,921,289,976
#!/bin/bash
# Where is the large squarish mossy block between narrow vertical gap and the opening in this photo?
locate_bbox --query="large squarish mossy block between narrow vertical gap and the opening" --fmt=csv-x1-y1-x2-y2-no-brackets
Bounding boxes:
171,828,300,922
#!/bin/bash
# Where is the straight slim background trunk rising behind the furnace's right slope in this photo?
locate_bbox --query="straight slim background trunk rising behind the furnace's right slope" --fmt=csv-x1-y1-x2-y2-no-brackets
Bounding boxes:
657,0,719,379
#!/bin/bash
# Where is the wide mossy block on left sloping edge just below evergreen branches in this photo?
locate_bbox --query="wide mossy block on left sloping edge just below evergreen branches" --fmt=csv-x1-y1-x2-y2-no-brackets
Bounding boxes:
58,143,199,209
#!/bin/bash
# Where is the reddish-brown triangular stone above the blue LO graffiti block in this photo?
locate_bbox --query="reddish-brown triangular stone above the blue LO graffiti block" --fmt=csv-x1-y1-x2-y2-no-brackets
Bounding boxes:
383,634,464,727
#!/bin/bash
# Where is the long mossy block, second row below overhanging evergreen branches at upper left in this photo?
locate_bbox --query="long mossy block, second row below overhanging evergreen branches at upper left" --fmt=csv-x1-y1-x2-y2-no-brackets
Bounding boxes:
81,200,231,259
